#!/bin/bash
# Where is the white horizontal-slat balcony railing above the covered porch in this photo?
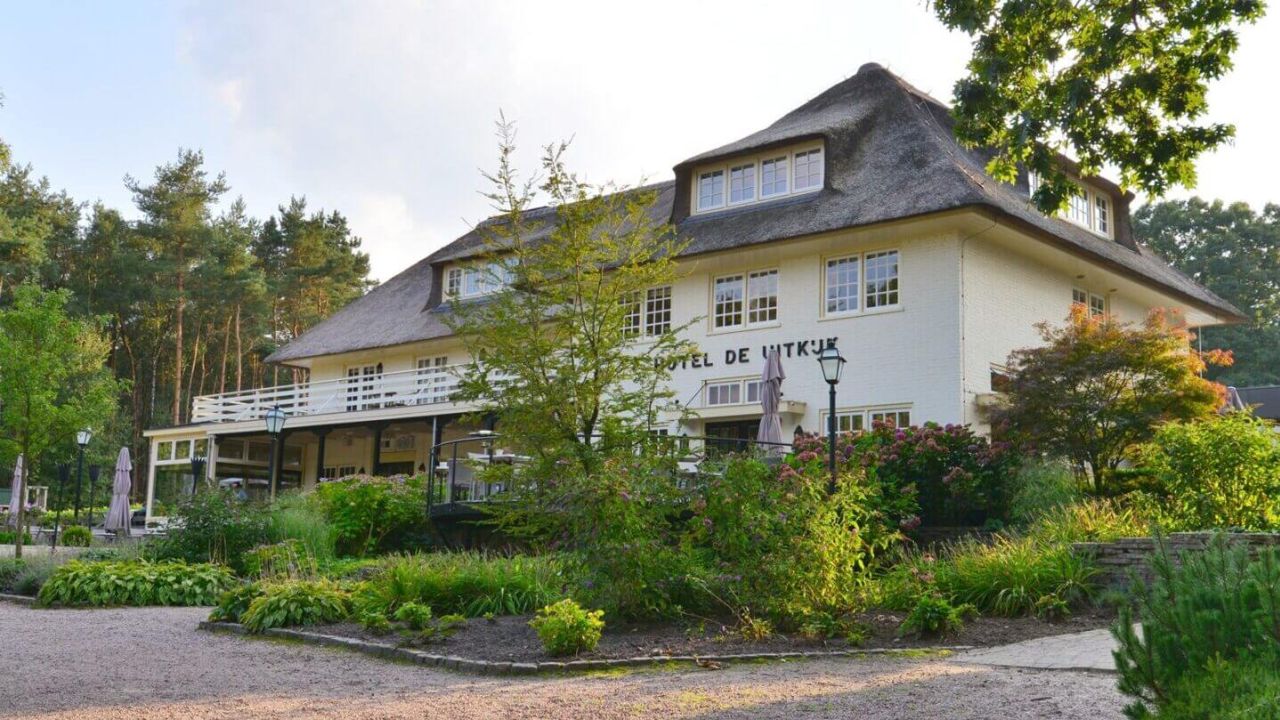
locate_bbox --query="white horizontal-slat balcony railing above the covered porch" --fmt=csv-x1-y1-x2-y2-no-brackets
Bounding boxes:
191,365,458,423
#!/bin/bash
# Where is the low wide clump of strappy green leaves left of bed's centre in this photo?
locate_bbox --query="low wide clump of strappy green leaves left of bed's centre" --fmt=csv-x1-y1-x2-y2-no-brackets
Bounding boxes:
355,552,563,618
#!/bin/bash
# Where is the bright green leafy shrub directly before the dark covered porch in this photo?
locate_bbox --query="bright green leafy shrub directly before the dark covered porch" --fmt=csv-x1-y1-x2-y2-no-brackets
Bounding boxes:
314,475,430,556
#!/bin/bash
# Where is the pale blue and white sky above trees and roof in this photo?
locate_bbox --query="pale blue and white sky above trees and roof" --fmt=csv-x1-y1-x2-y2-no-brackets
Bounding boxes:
0,0,1280,279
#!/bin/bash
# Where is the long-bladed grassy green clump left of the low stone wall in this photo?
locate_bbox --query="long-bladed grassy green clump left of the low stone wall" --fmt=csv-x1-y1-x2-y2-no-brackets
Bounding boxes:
873,534,1097,618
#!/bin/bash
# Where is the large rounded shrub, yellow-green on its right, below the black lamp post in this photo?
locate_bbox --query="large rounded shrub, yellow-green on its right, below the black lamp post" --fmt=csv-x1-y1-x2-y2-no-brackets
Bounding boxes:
691,451,897,626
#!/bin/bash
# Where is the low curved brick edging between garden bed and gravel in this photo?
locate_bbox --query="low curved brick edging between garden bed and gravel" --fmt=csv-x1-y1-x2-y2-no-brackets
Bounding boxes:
200,620,973,675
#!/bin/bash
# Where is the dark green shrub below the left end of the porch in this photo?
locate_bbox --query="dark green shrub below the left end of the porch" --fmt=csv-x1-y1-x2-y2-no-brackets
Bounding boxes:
151,491,268,573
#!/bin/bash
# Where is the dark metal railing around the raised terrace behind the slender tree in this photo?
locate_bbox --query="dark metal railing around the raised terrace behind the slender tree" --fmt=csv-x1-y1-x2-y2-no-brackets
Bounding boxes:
426,430,791,514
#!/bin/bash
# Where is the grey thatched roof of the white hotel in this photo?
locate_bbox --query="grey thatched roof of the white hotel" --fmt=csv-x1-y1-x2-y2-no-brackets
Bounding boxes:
268,64,1243,363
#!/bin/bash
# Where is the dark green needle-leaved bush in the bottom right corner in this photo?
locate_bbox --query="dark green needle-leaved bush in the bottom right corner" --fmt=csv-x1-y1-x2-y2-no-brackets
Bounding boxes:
1111,536,1280,719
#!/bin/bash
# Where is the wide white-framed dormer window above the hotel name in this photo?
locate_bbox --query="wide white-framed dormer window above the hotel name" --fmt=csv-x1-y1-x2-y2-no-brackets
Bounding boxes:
694,143,824,214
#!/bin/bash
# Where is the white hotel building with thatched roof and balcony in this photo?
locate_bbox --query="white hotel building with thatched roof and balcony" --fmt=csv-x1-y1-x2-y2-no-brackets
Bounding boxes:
146,64,1242,516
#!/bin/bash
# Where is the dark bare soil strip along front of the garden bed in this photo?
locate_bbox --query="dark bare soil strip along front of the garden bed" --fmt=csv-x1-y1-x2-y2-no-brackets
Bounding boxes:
305,599,1112,662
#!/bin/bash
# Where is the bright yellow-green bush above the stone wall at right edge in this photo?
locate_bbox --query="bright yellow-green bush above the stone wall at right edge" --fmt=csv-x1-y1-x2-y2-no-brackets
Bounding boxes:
1140,413,1280,530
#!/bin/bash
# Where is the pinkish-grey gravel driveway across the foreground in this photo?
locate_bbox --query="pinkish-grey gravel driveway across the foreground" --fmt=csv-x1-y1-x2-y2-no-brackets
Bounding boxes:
0,603,1123,720
